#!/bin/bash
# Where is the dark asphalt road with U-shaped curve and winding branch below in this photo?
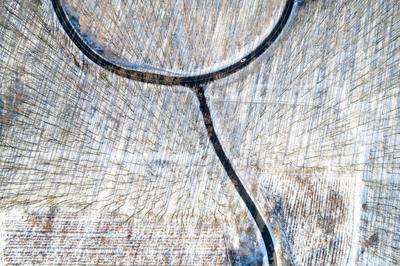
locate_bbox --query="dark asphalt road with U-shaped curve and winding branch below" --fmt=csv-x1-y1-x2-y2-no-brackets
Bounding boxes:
51,0,303,265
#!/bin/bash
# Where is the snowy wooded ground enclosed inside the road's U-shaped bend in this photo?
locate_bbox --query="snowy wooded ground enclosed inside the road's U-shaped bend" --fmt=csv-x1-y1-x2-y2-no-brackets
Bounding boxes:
63,0,285,74
